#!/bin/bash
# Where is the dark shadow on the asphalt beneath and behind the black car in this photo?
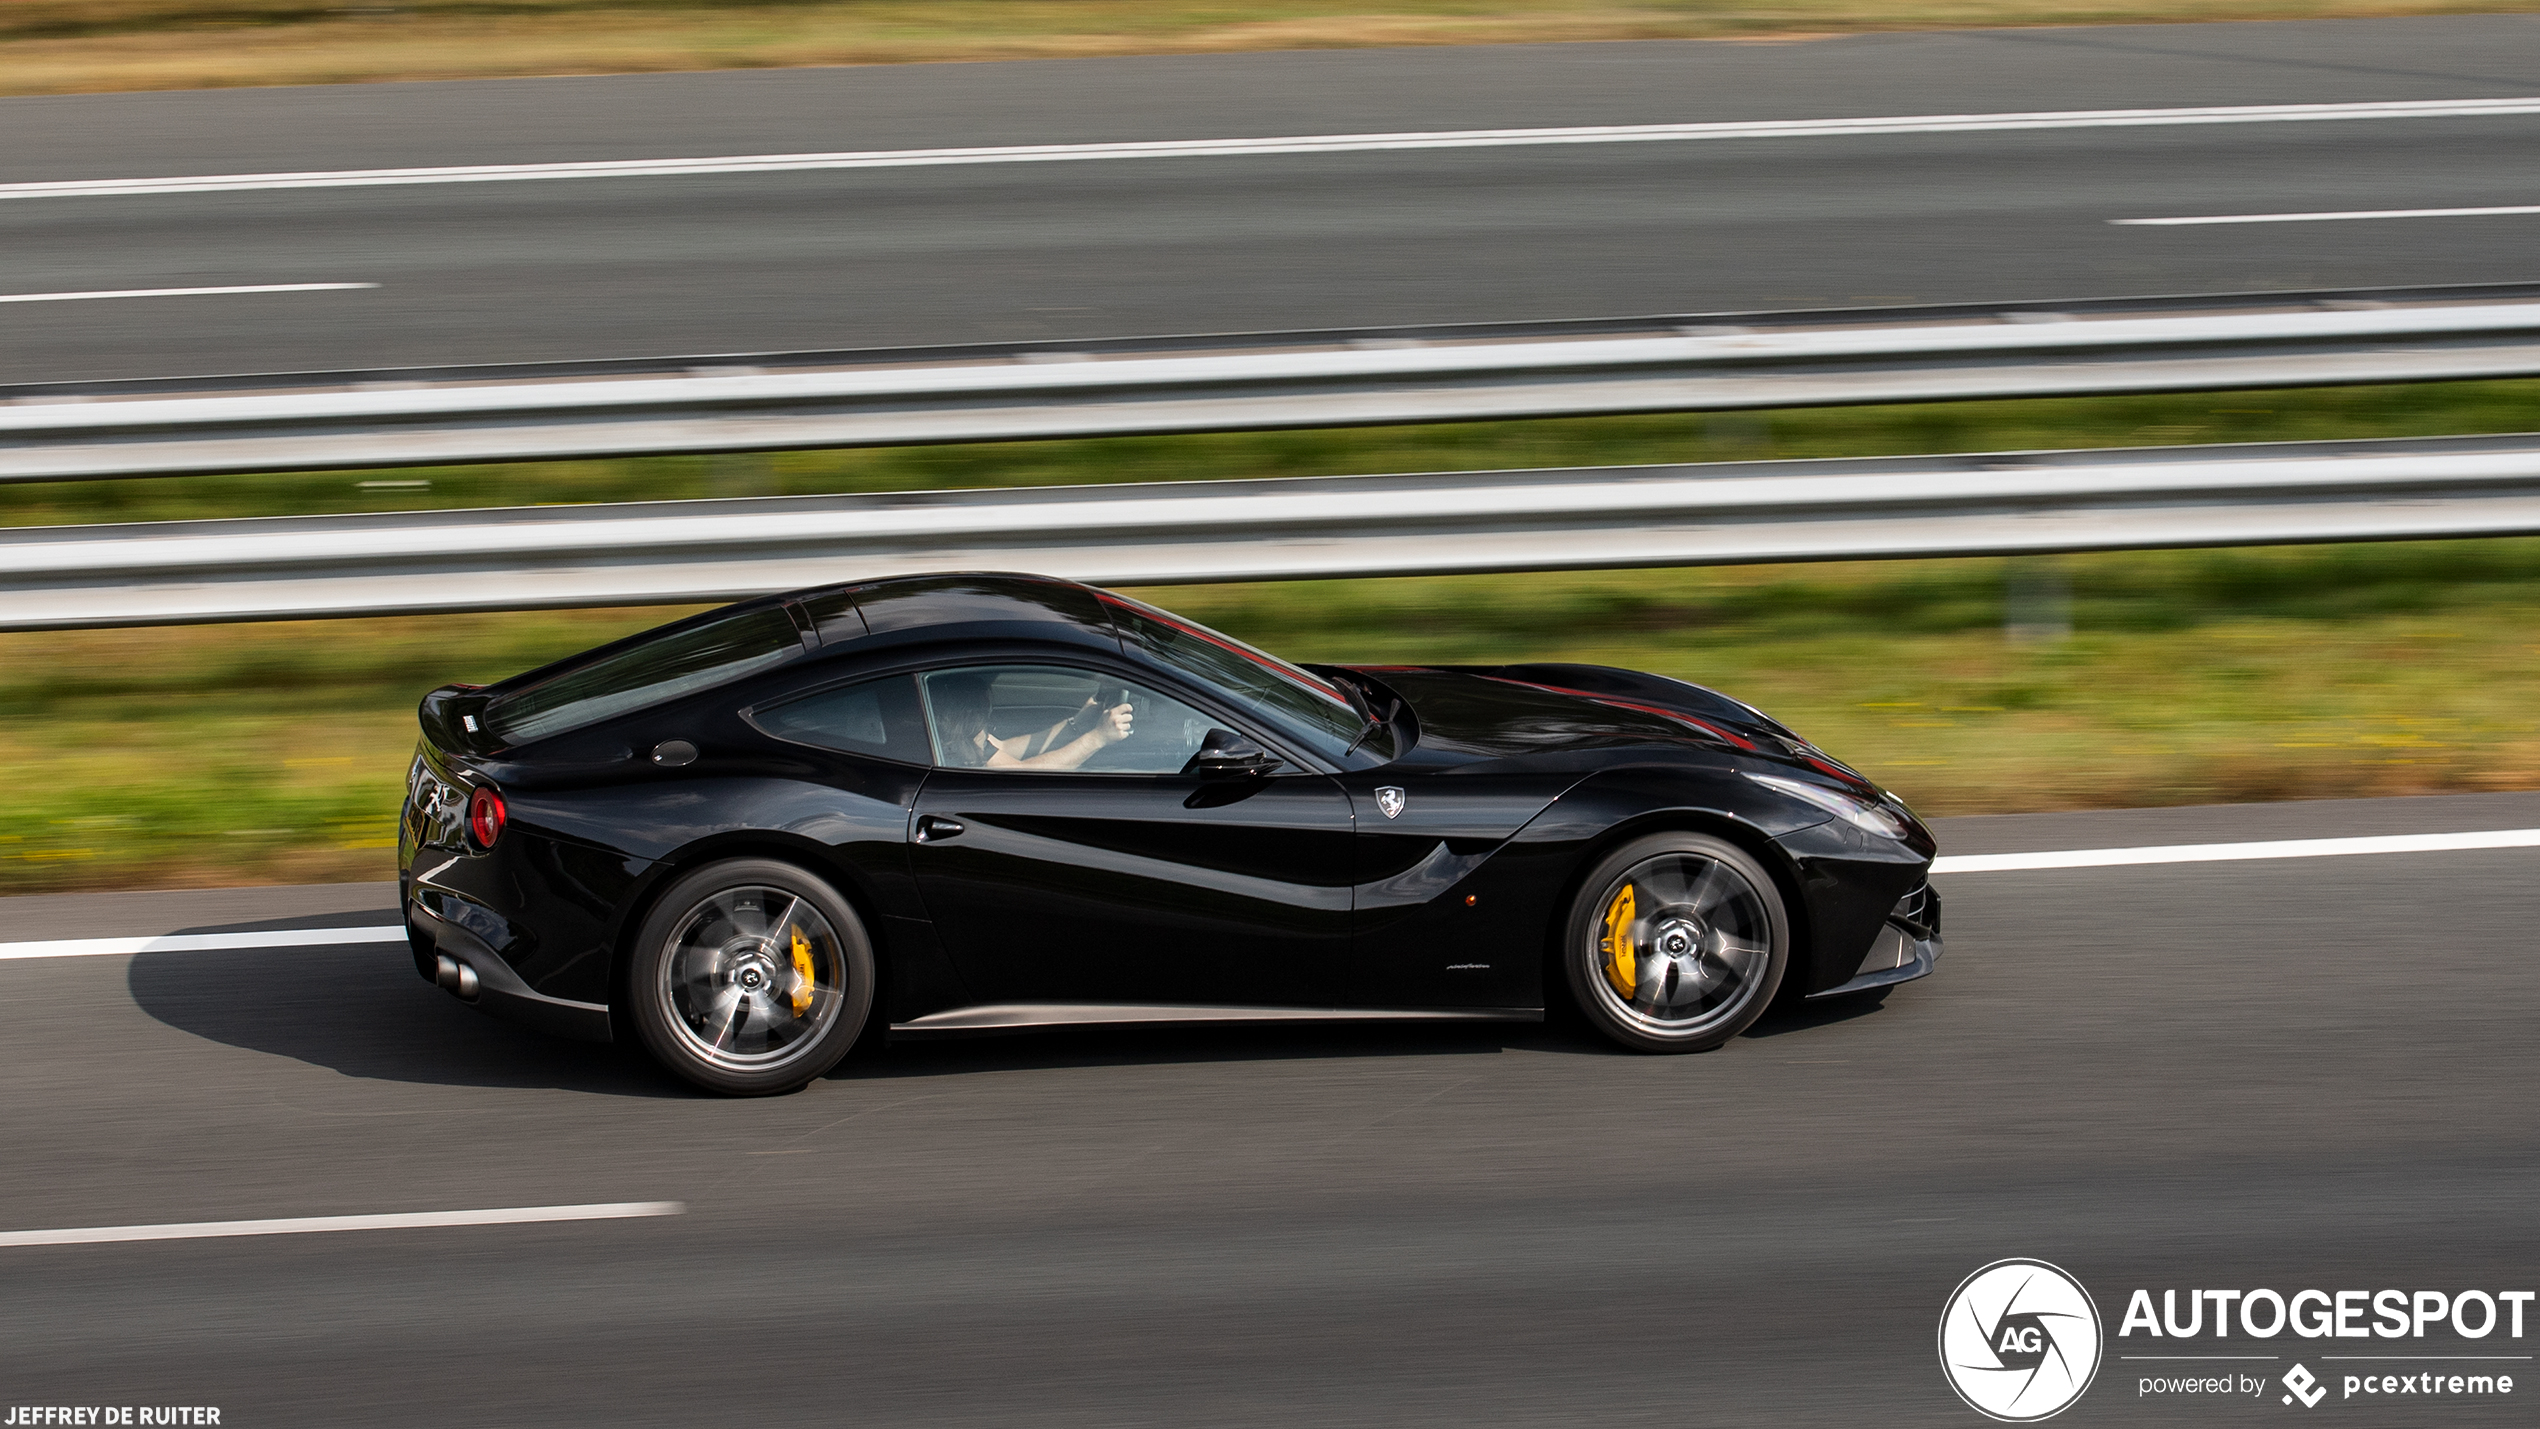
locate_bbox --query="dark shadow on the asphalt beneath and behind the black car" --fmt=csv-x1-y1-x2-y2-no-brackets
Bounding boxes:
127,919,1880,1096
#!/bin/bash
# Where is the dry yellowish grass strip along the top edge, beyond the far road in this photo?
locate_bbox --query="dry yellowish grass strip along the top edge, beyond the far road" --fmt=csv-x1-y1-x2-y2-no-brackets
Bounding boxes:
0,0,2540,94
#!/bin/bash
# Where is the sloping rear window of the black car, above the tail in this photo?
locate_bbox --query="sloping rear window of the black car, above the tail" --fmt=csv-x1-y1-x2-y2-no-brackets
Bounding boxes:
485,607,803,744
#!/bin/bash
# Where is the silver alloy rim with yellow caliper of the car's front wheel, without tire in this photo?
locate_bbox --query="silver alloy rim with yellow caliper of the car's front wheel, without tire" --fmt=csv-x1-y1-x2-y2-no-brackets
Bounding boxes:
1580,853,1773,1041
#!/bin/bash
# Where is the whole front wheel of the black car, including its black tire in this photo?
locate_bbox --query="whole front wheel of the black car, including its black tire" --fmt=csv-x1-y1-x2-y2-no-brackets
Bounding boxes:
1560,833,1791,1051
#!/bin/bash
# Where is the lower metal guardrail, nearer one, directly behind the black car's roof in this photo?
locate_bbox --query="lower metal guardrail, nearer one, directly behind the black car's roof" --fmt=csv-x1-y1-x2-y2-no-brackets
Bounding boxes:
0,434,2540,629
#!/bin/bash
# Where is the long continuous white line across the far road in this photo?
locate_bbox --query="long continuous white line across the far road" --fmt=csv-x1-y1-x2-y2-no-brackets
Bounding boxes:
0,96,2540,198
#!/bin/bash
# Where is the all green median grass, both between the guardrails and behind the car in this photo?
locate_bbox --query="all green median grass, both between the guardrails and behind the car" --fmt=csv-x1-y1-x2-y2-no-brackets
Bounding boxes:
0,381,2540,893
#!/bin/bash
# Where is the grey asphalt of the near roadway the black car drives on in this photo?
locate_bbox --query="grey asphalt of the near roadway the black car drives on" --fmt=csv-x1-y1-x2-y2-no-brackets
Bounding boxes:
0,794,2540,1429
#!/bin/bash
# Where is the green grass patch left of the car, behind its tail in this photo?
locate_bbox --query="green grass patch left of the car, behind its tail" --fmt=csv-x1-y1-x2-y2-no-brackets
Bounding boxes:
0,612,660,893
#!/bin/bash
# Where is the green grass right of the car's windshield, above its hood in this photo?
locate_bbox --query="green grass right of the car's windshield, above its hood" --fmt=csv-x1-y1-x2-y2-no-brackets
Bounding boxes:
1161,541,2540,815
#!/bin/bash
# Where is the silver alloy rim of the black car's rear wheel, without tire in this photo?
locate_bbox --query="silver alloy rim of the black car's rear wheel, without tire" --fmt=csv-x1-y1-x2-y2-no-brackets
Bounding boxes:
655,883,846,1071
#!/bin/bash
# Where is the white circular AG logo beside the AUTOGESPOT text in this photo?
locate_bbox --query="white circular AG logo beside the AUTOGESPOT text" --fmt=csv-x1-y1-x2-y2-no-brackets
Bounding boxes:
1941,1259,2101,1424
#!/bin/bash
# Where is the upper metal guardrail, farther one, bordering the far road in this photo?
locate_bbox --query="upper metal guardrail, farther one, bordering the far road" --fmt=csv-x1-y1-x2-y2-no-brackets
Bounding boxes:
14,284,2540,480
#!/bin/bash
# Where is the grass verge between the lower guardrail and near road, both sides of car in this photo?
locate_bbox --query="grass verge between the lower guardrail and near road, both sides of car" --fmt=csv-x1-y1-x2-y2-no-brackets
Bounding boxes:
0,541,2540,893
